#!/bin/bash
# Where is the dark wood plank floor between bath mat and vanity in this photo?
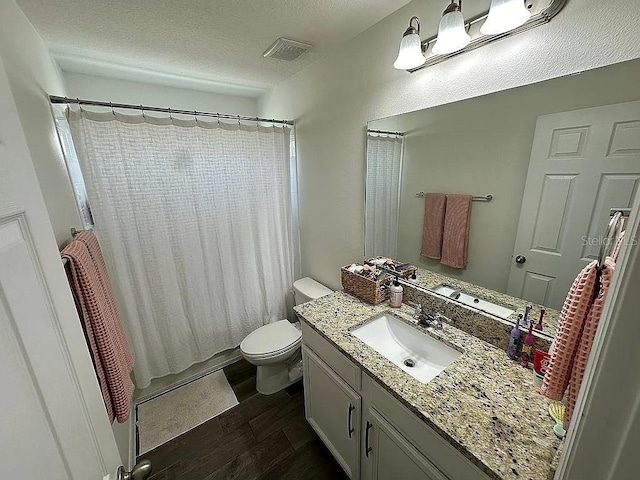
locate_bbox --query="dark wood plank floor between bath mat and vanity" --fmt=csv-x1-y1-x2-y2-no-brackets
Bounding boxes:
138,360,347,480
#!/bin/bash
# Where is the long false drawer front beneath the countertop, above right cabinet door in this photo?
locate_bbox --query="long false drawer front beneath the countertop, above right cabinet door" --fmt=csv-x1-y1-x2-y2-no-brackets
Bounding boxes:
362,375,489,480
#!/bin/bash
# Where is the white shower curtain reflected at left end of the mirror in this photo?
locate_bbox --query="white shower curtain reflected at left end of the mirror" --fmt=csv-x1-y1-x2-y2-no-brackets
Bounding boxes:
364,132,403,258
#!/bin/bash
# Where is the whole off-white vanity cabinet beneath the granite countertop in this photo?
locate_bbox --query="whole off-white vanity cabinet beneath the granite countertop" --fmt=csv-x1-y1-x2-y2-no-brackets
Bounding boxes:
301,321,489,480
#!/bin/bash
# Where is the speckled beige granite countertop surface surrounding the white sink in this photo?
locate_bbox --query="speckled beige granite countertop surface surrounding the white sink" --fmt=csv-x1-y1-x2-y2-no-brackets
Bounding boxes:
295,292,561,480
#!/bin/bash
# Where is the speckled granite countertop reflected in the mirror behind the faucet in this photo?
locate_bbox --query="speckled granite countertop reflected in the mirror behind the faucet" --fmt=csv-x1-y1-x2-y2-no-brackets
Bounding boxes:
405,267,560,338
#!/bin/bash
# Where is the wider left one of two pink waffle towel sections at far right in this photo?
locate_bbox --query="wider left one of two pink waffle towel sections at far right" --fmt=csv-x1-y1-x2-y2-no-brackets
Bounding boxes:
540,261,597,400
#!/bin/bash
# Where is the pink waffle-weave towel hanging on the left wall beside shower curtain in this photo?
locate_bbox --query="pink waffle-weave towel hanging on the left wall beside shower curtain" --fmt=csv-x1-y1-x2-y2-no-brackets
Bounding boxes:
61,231,135,423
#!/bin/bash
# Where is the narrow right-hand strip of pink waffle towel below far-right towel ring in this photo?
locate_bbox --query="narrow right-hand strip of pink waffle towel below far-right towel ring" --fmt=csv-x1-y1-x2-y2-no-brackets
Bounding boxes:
564,257,616,429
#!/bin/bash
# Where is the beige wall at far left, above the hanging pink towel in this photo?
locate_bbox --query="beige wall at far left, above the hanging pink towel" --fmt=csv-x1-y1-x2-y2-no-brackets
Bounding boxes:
0,0,81,244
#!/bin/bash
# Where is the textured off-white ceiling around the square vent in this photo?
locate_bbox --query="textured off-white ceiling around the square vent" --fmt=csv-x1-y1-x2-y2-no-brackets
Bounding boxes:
17,0,416,94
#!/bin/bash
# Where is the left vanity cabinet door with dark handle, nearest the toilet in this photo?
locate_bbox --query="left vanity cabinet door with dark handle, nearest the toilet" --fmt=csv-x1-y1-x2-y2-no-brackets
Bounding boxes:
302,347,361,480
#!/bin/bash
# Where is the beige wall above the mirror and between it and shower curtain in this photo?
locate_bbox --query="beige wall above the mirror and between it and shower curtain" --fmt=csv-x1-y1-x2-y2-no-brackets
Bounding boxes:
262,0,640,289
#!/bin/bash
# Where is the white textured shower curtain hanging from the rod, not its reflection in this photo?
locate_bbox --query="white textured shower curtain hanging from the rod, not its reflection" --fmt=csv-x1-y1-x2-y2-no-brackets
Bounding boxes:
67,110,299,388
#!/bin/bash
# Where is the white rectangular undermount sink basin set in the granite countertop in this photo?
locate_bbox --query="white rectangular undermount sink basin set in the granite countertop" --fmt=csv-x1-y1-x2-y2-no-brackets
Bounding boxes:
351,314,461,383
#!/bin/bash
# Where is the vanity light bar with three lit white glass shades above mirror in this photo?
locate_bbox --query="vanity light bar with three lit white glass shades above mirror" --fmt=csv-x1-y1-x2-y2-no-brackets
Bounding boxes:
393,0,569,73
